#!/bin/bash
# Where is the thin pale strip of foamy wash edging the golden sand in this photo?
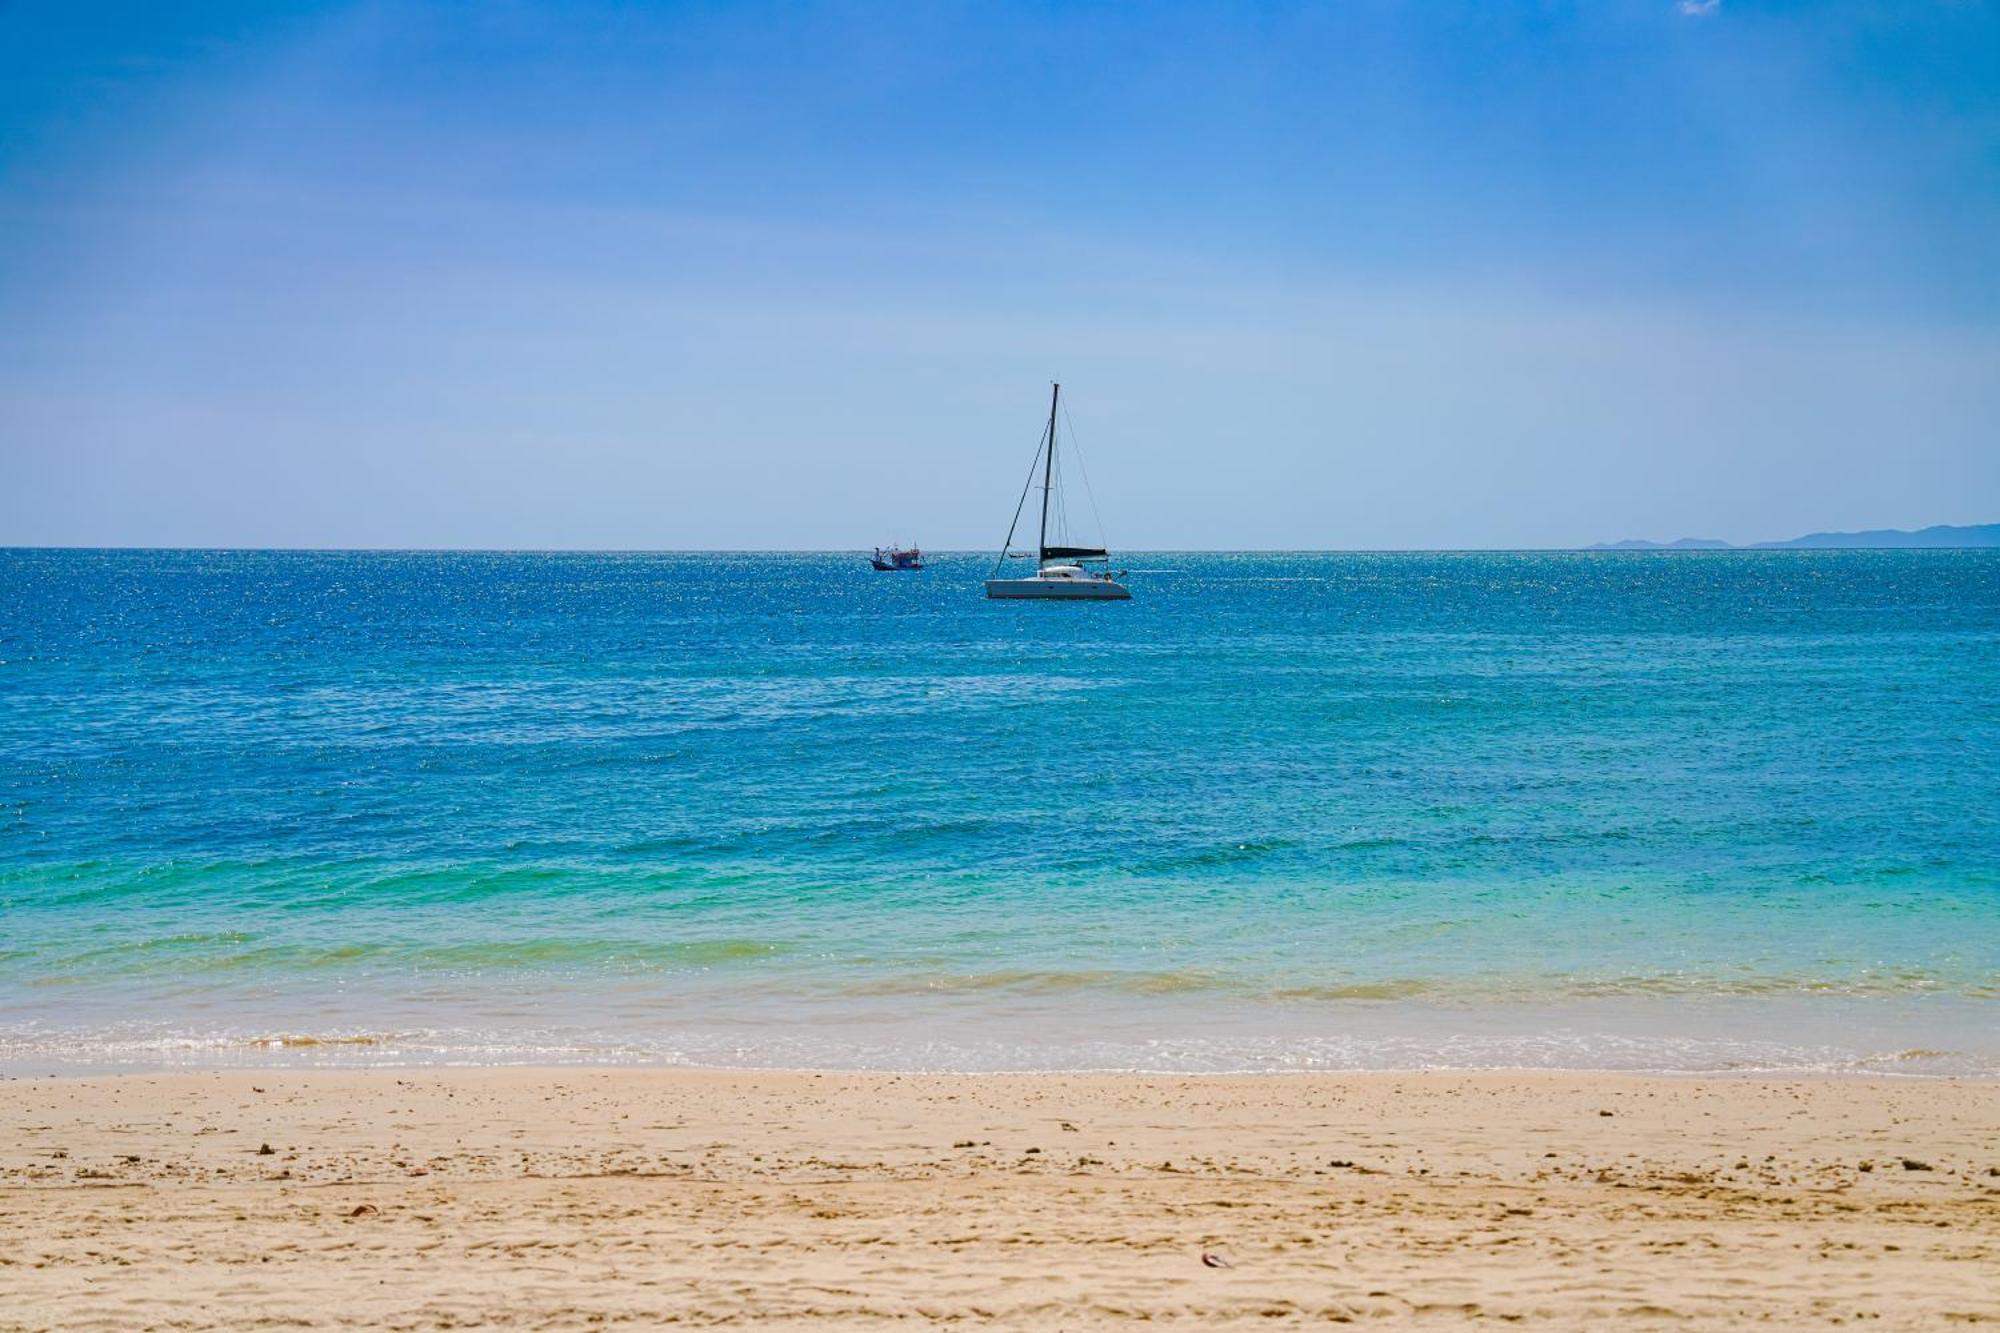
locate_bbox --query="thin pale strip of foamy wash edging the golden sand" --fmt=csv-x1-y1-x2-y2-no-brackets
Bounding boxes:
0,1003,2000,1077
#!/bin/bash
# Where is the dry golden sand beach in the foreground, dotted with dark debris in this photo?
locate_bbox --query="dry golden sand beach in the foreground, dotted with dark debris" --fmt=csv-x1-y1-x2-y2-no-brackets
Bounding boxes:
0,1069,2000,1329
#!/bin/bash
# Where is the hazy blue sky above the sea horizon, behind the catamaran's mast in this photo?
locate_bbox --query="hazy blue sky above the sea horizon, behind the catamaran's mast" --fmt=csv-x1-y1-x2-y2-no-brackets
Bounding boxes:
0,0,2000,550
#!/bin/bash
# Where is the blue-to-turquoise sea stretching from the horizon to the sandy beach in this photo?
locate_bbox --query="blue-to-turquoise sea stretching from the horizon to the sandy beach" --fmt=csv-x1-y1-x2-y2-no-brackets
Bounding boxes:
0,550,2000,1073
